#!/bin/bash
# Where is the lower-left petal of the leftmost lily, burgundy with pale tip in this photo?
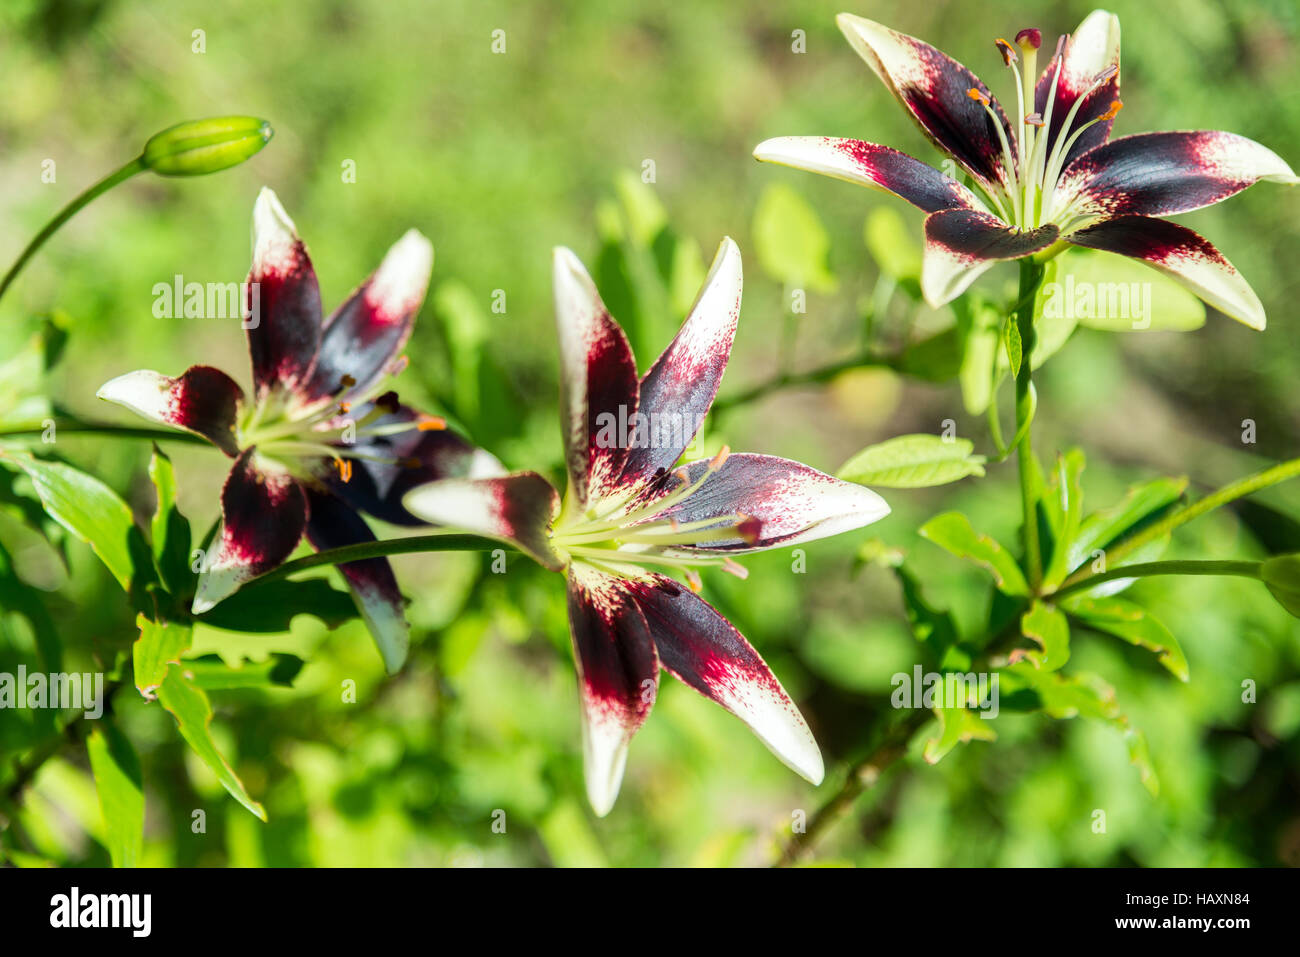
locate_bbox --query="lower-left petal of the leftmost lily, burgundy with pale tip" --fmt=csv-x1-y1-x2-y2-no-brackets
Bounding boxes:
192,449,307,615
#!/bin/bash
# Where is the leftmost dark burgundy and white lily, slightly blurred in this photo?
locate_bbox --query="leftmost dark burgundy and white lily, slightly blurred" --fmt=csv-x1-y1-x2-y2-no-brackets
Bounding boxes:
98,189,501,672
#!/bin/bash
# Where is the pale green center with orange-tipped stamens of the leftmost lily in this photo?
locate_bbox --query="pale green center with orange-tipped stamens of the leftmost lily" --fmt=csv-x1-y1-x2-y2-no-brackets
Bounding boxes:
235,376,447,482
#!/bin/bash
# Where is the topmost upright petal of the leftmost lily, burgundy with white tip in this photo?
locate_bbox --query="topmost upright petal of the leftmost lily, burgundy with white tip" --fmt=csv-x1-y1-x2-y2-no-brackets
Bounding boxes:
244,187,321,395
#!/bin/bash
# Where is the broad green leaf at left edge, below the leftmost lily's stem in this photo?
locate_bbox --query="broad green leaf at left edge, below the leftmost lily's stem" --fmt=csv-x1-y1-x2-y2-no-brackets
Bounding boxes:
4,452,140,590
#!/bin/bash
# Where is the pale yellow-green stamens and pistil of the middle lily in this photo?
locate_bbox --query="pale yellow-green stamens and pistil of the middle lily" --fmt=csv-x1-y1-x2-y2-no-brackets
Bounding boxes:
551,449,761,590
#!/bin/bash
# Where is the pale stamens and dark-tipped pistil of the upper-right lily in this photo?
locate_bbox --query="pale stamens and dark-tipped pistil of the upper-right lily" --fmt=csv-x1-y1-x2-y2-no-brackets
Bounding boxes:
966,30,1123,231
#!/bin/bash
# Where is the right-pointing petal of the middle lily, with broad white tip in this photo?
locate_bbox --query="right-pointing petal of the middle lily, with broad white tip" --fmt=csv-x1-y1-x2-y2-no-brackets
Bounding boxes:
655,452,889,553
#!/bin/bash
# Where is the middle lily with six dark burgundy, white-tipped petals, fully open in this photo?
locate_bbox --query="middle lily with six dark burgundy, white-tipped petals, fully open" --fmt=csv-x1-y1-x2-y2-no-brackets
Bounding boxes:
404,239,889,815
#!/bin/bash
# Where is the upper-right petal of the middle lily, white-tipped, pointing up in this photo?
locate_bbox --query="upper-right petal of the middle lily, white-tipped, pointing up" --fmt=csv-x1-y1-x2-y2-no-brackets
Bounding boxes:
624,237,742,481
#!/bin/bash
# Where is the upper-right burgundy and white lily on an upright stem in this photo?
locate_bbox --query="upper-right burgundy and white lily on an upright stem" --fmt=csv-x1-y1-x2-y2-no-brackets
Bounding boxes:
754,10,1297,329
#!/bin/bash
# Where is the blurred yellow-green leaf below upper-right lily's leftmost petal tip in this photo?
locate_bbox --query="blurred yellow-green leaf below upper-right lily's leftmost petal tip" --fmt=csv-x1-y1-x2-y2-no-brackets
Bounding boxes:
754,183,839,294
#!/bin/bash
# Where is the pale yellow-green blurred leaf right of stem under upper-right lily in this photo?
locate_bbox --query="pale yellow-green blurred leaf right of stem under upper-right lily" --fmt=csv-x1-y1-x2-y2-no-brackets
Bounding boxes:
1043,248,1205,333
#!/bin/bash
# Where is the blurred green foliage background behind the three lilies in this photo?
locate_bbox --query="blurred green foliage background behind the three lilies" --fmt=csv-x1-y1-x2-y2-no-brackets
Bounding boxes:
0,0,1300,866
